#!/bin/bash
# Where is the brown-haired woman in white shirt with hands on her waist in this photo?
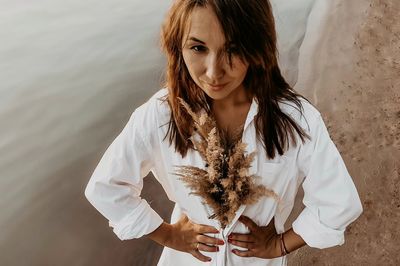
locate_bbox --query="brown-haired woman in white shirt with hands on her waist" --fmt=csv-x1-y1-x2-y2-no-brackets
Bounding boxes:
85,0,362,265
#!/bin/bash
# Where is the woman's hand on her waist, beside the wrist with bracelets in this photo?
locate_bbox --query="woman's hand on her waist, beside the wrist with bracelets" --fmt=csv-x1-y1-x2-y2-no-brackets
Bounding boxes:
228,215,281,259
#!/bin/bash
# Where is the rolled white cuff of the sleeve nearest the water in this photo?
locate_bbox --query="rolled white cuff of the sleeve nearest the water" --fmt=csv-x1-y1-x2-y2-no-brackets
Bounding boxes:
110,200,164,240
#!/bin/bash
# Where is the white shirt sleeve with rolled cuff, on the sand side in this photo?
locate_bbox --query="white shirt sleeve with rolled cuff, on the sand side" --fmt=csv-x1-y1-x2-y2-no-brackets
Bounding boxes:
292,114,363,249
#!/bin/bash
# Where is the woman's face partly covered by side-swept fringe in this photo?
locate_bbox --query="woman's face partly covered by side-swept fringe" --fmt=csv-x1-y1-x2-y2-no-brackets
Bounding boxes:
182,7,248,100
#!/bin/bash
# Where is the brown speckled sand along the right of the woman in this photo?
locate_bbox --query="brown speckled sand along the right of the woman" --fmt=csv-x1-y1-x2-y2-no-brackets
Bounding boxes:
288,0,400,266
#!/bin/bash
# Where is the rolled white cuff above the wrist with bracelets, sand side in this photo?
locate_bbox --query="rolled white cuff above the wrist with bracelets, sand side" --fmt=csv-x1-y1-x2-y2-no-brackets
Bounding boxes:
292,207,345,249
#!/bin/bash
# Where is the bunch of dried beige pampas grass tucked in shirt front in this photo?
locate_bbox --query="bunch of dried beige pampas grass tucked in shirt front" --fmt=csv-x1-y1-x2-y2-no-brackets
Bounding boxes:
175,98,278,228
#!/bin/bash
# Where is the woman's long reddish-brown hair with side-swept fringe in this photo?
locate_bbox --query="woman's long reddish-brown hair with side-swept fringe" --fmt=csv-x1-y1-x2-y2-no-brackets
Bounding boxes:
161,0,309,158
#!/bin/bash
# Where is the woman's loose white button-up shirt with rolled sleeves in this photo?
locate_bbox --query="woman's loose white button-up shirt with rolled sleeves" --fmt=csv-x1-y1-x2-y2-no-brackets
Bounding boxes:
85,88,363,266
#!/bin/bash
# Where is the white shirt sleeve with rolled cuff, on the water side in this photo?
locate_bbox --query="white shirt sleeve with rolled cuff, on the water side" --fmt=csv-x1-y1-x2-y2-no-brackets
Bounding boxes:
85,108,163,240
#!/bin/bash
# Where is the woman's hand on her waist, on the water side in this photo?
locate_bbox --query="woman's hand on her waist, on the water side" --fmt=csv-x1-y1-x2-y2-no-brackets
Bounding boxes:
164,214,224,262
